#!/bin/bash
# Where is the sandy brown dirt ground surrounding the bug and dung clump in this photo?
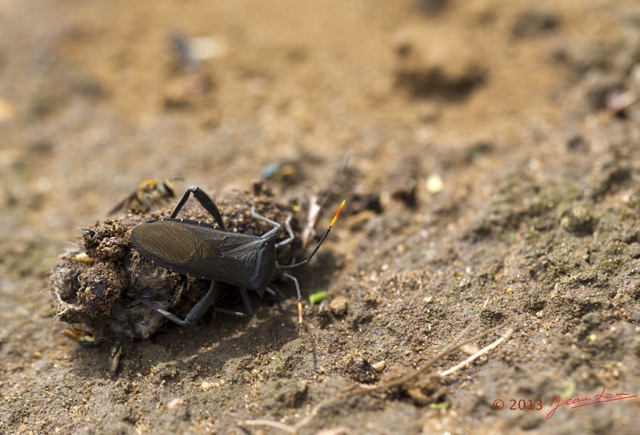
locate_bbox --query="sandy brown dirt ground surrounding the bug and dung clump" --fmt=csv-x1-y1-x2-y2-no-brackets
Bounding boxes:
0,0,640,434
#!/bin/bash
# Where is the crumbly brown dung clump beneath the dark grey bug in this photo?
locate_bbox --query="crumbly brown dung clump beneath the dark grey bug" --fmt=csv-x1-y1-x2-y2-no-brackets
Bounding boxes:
51,186,301,342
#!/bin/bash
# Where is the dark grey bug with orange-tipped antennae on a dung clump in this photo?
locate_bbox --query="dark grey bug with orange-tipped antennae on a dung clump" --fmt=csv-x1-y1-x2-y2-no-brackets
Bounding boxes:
131,186,346,325
